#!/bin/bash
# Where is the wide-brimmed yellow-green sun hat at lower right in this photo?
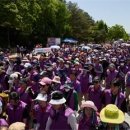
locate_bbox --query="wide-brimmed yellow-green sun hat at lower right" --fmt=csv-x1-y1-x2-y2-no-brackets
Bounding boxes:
100,104,125,124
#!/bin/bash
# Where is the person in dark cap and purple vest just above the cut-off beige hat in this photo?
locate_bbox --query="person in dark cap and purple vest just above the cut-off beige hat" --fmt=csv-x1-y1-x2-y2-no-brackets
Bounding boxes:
6,92,28,125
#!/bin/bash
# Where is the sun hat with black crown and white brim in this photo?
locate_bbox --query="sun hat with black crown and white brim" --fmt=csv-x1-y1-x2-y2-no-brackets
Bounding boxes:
49,91,66,105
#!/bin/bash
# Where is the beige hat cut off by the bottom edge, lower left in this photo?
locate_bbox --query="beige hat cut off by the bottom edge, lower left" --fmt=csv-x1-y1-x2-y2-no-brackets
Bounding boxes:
8,122,25,130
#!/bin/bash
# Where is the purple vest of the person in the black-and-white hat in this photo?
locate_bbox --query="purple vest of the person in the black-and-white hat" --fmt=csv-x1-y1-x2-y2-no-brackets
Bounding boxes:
50,108,73,130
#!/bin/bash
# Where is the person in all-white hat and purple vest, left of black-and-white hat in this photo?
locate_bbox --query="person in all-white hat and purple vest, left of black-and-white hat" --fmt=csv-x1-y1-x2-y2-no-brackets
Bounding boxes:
33,93,51,130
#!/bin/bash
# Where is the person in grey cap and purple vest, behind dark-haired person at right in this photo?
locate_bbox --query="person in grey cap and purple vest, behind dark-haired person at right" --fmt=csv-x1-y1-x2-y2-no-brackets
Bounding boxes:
105,63,118,89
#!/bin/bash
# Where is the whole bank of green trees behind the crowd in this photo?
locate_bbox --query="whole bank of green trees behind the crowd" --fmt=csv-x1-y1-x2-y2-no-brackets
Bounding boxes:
0,0,129,46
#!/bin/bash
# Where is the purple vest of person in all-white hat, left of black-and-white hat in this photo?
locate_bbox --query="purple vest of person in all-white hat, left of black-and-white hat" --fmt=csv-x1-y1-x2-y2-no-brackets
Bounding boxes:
34,104,51,130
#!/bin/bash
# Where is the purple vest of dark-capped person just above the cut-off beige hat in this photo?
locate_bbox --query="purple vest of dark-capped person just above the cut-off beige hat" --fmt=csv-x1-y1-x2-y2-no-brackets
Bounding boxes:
7,101,26,124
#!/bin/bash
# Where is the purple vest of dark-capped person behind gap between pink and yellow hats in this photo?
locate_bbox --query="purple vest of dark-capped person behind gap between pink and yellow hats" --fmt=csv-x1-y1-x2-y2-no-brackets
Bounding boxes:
88,86,103,111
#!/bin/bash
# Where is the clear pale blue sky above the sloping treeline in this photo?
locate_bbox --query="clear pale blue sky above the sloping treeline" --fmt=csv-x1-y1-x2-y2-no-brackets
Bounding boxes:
66,0,130,33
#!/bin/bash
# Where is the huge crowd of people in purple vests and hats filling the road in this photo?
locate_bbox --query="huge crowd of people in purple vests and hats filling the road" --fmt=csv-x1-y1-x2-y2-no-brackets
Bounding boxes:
0,44,130,130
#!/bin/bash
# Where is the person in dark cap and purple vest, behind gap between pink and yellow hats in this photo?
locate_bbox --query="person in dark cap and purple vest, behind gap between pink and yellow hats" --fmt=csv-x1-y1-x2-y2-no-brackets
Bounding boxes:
88,76,103,111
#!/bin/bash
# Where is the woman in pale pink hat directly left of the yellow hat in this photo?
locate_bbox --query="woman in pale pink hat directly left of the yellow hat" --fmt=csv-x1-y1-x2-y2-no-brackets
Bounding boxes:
78,101,98,130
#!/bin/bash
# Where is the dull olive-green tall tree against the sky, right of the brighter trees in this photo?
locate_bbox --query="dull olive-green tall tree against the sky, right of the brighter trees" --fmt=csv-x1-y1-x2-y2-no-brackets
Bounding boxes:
67,2,94,41
